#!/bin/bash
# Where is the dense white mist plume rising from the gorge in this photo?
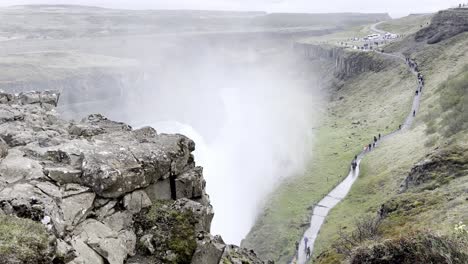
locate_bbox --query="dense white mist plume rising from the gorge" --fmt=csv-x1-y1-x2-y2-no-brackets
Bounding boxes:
117,37,322,244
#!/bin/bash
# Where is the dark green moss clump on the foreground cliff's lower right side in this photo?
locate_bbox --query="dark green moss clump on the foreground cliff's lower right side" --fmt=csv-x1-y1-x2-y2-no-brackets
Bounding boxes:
135,201,197,264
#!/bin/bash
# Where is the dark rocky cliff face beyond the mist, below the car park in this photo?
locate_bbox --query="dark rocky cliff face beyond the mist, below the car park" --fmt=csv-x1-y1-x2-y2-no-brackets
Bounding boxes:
295,43,388,79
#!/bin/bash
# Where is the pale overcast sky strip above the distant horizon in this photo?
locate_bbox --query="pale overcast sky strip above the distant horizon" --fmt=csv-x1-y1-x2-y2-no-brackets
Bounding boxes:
0,0,462,17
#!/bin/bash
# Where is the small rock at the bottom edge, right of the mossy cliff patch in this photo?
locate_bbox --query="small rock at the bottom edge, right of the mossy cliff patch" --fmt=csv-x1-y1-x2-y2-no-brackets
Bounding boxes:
191,233,226,264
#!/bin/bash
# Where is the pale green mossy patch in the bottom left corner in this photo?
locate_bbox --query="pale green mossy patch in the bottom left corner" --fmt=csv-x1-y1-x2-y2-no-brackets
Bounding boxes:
0,215,50,264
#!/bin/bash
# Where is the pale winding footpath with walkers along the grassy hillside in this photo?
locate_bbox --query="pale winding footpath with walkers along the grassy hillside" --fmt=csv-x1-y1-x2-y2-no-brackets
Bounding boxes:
291,22,424,264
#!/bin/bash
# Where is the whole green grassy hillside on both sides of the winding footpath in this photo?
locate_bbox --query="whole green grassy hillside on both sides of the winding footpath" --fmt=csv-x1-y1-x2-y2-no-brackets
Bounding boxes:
244,11,468,263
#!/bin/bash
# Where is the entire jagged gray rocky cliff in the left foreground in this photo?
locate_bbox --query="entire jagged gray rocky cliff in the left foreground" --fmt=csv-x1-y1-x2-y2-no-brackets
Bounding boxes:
0,91,263,264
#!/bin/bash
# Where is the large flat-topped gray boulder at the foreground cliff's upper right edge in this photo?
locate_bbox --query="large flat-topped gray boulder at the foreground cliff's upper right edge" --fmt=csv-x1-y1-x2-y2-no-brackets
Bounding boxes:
82,132,193,198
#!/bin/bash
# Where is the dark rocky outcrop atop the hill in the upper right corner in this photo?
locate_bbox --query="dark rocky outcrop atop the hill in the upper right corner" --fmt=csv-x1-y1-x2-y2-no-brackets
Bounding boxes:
415,8,468,44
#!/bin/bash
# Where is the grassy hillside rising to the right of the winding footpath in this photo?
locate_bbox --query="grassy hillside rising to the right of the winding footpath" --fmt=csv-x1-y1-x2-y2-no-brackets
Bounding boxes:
315,26,468,263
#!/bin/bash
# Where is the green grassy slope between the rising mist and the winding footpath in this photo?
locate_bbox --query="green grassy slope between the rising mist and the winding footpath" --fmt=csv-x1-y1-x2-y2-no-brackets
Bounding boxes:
242,49,414,263
